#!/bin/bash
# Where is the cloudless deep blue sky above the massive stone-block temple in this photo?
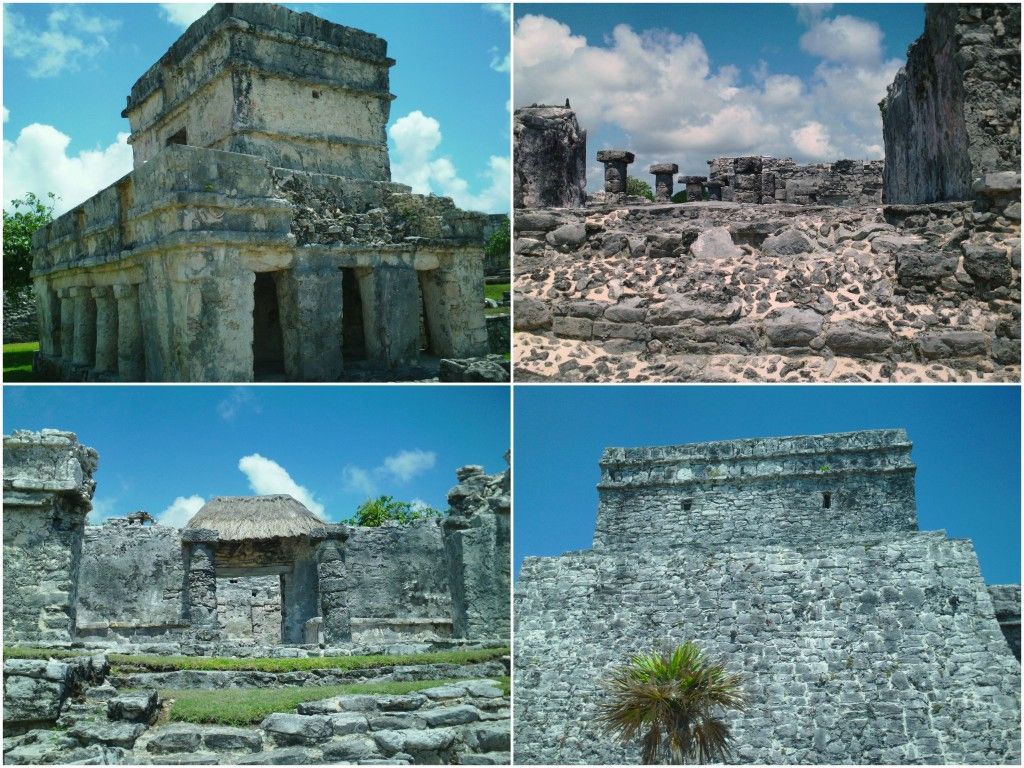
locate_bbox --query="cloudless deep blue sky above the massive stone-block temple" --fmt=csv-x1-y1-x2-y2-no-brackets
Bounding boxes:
513,385,1021,584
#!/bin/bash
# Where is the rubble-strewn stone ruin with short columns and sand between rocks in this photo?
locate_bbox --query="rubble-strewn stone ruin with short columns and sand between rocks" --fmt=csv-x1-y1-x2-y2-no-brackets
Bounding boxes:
514,4,1021,382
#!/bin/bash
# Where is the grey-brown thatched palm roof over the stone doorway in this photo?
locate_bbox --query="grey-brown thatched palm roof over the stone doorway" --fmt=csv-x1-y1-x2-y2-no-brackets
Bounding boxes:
185,495,324,542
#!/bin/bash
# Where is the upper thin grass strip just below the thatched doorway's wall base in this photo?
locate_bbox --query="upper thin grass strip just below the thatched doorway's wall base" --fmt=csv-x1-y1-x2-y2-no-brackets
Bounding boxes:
3,648,509,672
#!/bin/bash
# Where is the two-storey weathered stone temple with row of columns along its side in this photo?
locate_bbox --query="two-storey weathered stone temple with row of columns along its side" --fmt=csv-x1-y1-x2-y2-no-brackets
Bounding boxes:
27,3,503,382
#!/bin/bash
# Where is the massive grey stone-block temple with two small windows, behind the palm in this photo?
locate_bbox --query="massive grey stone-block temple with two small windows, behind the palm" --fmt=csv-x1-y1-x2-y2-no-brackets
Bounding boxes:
514,429,1021,764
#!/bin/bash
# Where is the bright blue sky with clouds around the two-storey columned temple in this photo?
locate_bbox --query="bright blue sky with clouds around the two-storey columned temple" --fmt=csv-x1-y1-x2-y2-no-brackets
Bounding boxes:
3,3,510,212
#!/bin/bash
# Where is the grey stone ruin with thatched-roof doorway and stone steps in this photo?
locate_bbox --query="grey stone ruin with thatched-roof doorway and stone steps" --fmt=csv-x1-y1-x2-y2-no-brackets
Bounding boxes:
3,430,510,764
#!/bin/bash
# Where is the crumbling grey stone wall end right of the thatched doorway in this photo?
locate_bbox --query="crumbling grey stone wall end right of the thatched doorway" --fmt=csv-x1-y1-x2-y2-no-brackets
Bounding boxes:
444,454,511,638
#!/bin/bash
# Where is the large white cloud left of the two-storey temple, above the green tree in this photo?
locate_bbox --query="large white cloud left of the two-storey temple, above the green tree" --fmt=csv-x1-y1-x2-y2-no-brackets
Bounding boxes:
3,123,132,215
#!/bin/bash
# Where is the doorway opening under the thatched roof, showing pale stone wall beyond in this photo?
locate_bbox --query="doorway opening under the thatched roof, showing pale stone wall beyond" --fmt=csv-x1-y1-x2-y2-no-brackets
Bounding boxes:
217,573,284,645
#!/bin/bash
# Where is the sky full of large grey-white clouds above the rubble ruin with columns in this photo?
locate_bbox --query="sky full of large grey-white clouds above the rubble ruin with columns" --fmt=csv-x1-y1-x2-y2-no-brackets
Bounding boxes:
513,3,925,190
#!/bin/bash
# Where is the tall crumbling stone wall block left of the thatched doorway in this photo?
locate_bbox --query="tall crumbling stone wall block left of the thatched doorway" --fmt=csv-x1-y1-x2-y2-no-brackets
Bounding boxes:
3,429,99,643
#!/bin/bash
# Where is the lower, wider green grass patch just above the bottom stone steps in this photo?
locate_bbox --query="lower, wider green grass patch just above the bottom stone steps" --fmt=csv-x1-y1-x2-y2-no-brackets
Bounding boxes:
160,677,509,726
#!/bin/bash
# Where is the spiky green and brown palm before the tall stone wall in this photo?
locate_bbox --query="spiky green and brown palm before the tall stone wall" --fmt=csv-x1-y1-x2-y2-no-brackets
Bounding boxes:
599,642,744,765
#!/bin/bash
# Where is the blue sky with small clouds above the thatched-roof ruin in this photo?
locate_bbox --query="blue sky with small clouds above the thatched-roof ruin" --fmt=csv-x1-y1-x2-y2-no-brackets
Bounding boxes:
3,385,509,525
